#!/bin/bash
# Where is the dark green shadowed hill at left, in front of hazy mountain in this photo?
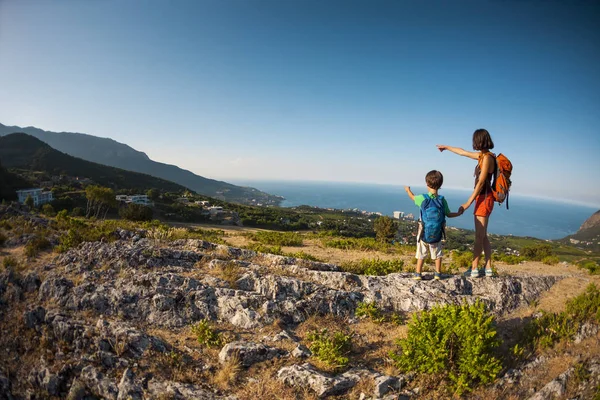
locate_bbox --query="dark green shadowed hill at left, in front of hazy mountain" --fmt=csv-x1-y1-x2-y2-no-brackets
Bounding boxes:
0,133,186,192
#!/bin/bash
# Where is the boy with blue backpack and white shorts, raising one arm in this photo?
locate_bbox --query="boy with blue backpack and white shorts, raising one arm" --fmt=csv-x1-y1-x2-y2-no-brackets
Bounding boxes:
404,170,463,281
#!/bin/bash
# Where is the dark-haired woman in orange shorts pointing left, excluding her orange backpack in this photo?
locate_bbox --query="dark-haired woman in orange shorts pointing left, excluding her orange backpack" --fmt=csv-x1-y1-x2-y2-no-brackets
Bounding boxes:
437,129,496,277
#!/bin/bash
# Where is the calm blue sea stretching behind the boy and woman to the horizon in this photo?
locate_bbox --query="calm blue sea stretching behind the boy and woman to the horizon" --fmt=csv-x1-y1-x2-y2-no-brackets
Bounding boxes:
230,180,598,239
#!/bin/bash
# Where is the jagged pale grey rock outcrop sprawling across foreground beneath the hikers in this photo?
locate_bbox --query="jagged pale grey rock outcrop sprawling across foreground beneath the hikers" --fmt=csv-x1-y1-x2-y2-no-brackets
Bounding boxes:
0,231,572,400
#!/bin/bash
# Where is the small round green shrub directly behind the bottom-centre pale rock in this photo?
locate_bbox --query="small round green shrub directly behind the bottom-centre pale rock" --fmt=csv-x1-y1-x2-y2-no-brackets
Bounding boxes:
307,329,352,368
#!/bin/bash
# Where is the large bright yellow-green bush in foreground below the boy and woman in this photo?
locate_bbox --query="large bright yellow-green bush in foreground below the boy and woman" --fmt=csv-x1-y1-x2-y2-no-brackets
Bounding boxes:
390,301,502,395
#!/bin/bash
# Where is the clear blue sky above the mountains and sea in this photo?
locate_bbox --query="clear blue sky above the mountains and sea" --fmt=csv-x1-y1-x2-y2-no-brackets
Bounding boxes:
0,0,600,206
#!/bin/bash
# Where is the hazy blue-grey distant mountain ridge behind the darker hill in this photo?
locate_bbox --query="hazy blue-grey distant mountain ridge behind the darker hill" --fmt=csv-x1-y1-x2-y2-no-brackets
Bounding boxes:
0,124,281,204
